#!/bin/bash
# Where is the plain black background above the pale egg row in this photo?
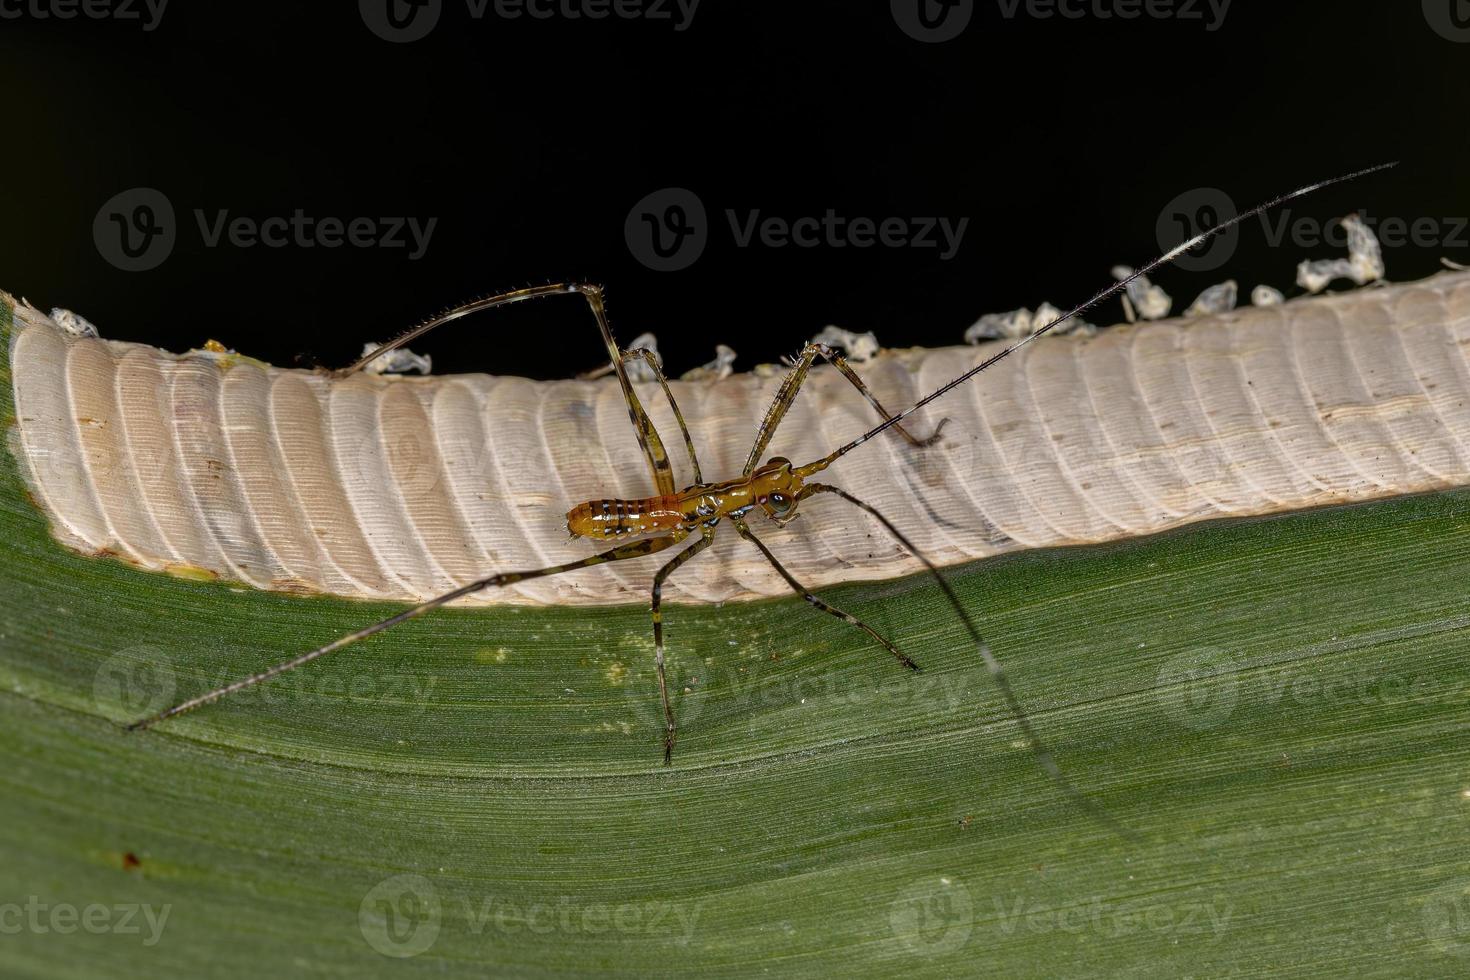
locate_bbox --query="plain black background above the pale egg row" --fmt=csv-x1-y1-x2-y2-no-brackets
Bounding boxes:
0,0,1470,378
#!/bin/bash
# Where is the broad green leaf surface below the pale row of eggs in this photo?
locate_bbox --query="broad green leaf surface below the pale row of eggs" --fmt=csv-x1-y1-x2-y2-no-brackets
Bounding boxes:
0,296,1470,977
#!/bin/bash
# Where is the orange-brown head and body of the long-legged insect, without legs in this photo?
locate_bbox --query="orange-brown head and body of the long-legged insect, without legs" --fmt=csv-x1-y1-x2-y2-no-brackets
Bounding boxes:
566,455,810,538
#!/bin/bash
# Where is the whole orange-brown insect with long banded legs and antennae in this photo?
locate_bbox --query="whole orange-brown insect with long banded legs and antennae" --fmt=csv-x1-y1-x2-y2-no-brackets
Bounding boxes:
128,163,1394,827
